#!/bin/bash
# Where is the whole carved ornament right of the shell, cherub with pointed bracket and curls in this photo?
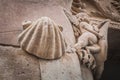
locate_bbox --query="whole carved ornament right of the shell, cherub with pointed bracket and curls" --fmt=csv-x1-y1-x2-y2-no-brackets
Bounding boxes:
64,9,110,80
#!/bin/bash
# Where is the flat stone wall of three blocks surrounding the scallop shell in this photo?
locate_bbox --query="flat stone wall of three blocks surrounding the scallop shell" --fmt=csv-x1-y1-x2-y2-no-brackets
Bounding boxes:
0,0,94,80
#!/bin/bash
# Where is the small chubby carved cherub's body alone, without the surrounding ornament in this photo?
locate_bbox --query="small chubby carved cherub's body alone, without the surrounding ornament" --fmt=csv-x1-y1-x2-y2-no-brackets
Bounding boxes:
75,13,102,49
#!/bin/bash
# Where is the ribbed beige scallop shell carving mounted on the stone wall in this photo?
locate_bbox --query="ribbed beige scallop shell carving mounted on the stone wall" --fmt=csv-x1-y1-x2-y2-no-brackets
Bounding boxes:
18,17,66,59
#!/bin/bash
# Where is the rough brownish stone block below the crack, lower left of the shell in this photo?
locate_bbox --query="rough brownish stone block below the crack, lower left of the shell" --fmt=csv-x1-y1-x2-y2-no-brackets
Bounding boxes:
0,46,40,80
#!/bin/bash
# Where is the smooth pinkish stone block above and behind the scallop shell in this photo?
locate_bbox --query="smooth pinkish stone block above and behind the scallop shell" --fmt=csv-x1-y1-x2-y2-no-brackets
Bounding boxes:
0,0,73,44
